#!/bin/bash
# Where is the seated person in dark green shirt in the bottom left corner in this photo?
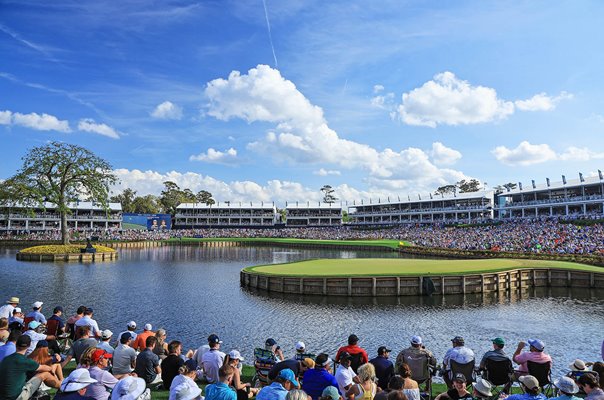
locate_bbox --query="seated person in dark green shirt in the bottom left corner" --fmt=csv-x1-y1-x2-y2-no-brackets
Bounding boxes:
0,335,61,400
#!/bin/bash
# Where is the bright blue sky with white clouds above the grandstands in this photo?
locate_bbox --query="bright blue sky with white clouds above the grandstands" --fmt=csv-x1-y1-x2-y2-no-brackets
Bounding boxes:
0,0,604,204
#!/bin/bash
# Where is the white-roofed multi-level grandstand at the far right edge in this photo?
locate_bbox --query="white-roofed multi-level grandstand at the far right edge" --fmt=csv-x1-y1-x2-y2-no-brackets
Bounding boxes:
495,176,604,219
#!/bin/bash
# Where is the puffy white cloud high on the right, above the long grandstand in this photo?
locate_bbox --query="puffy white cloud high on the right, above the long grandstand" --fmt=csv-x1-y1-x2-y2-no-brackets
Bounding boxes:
398,71,514,128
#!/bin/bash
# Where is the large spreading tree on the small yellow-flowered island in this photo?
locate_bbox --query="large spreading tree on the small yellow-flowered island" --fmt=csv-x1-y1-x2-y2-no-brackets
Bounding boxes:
4,142,118,244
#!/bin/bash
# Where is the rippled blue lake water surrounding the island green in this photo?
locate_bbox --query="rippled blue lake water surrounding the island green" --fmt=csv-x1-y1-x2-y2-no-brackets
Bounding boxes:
0,246,604,374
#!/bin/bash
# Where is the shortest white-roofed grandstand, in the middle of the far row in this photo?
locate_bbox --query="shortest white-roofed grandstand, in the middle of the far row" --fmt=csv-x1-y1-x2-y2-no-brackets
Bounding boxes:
285,203,342,228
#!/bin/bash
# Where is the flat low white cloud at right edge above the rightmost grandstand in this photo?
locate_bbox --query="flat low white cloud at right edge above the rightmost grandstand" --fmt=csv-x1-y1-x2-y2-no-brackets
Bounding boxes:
491,140,604,166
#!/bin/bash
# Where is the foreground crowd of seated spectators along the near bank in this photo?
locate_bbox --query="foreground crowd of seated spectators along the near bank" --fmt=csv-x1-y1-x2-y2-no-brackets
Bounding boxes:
0,297,604,400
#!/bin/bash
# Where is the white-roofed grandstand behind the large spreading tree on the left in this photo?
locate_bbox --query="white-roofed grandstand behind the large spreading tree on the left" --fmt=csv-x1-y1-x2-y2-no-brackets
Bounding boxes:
0,201,122,232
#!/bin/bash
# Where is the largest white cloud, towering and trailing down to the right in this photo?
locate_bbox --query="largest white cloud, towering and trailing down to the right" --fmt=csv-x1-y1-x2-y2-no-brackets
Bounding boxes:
205,65,463,190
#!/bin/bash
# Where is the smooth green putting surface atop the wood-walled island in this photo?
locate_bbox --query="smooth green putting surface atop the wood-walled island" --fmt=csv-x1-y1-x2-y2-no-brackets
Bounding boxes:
244,258,604,277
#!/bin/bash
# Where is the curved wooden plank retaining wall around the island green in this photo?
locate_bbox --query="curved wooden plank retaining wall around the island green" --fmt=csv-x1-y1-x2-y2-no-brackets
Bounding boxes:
240,268,604,297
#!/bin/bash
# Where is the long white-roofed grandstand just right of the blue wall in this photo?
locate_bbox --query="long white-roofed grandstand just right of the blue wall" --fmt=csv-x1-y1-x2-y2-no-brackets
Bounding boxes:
173,203,279,229
